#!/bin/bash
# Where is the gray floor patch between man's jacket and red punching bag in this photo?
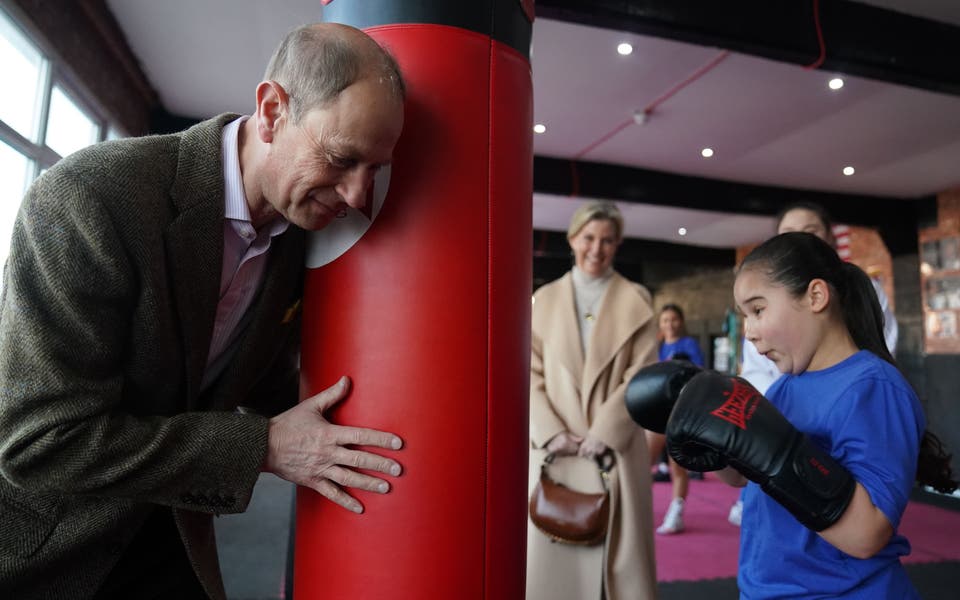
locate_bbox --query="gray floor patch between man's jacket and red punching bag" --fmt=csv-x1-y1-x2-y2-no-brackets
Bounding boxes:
215,473,294,600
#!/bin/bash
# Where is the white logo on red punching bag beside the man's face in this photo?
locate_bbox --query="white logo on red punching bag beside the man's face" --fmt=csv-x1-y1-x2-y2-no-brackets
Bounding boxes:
307,165,390,269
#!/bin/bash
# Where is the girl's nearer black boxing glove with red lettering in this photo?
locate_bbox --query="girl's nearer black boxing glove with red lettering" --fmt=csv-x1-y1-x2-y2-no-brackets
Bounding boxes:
667,372,856,531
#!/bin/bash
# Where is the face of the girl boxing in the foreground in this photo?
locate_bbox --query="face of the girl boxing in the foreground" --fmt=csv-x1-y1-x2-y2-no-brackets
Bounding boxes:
733,268,822,375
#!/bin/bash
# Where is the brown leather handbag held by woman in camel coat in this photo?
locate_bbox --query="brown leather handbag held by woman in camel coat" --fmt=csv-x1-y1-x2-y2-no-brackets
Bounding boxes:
530,452,613,546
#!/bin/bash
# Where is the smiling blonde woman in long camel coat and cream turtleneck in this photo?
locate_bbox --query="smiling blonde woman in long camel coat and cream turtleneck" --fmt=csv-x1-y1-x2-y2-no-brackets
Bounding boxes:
526,202,657,600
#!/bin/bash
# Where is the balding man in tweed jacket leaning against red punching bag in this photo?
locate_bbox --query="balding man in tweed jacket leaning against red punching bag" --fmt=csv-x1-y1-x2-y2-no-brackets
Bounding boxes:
0,24,404,600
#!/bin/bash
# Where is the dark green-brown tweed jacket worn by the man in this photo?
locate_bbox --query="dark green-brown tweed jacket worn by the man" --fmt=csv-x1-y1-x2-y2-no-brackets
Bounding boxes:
0,115,304,600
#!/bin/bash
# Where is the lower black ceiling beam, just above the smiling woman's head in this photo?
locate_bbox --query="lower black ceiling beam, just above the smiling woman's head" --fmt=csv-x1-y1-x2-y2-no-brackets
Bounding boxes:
533,156,931,255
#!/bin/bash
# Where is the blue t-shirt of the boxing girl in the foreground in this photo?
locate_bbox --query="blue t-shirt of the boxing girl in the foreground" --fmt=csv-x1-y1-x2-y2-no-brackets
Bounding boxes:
737,351,926,600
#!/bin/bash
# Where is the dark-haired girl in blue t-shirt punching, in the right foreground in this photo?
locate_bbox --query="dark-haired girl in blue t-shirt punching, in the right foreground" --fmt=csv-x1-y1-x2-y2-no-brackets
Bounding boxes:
666,232,957,599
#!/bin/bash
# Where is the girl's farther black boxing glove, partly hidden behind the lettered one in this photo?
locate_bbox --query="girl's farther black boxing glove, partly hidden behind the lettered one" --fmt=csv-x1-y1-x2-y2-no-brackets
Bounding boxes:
624,360,701,433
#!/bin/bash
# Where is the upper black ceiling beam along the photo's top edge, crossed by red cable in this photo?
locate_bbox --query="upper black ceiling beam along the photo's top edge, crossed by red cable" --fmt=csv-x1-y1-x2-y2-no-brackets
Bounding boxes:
536,0,960,95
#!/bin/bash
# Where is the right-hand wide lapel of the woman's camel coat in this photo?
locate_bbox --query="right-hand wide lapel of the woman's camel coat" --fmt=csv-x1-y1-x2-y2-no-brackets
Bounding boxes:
580,272,653,402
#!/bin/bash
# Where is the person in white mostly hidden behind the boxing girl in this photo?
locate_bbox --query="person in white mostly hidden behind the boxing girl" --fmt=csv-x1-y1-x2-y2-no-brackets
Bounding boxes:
727,202,899,525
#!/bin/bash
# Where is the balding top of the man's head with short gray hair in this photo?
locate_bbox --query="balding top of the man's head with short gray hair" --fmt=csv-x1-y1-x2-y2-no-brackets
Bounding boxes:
264,25,406,123
